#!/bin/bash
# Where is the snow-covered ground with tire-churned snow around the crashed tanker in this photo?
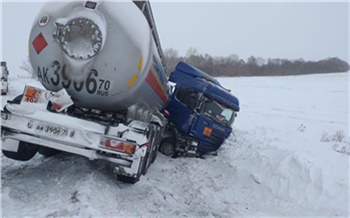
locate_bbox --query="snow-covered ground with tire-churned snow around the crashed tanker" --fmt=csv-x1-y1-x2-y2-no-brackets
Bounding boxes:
1,70,350,217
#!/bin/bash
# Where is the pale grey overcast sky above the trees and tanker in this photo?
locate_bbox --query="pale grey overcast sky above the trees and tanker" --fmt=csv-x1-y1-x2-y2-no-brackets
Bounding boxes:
0,0,350,71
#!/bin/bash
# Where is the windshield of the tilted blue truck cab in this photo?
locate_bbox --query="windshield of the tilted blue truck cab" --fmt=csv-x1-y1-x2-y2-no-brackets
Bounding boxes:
201,99,235,127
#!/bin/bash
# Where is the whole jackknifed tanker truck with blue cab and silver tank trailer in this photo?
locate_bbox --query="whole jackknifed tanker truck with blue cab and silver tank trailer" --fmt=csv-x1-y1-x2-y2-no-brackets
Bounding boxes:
1,1,239,183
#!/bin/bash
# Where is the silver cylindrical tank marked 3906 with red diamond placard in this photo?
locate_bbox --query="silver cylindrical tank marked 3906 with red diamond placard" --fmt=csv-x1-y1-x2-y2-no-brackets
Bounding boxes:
29,1,170,117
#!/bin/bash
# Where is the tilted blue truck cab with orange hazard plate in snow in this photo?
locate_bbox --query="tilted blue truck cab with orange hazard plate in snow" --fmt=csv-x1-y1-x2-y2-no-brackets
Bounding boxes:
160,62,240,157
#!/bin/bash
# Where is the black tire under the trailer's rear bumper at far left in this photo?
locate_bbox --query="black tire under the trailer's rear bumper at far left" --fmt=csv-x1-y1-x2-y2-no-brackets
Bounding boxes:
2,142,39,161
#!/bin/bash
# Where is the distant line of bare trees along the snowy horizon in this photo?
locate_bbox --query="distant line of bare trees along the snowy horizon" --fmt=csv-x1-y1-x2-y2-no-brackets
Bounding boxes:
164,48,349,77
